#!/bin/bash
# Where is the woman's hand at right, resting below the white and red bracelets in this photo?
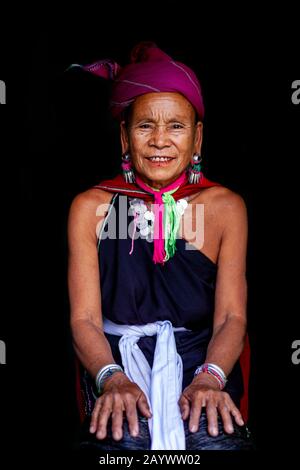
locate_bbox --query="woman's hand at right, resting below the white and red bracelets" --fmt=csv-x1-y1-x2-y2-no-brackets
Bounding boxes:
178,373,244,436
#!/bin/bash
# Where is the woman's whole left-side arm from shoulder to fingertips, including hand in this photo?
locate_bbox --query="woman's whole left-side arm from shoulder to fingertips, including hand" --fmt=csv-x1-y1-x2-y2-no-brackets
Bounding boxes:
68,190,151,440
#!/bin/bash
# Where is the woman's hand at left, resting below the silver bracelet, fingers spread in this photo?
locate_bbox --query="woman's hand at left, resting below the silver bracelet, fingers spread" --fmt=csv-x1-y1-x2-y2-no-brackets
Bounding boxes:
90,372,152,441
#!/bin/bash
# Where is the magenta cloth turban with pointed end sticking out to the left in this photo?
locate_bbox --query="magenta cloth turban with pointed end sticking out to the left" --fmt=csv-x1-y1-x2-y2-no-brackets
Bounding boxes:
74,42,204,120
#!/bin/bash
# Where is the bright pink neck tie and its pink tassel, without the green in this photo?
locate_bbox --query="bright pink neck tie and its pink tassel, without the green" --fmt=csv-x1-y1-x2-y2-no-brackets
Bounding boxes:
136,171,187,264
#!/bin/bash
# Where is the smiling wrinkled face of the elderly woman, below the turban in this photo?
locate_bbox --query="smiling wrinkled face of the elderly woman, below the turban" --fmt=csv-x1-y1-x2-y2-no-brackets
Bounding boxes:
121,93,202,189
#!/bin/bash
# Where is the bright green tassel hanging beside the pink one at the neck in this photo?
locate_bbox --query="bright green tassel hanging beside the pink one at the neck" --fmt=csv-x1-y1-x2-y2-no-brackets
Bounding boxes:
162,188,181,261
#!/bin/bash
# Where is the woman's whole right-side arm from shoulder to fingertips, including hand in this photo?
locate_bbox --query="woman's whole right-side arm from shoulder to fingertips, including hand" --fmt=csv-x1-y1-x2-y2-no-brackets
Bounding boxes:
179,190,247,436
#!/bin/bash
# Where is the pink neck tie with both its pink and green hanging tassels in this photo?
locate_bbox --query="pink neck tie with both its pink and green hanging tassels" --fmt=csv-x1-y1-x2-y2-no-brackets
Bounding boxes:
136,172,187,264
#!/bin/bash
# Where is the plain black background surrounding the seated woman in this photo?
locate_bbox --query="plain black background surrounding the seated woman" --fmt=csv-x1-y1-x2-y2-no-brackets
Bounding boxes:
0,9,300,468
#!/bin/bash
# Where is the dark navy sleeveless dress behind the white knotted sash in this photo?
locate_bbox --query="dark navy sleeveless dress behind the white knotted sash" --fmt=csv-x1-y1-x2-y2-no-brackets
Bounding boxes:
81,193,243,414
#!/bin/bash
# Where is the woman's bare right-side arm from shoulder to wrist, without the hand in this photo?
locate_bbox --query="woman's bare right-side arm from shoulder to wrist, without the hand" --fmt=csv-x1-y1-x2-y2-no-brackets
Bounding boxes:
206,192,248,375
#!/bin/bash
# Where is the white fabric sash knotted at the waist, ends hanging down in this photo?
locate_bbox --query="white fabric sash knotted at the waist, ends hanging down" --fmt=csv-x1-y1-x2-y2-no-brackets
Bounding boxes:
103,318,189,450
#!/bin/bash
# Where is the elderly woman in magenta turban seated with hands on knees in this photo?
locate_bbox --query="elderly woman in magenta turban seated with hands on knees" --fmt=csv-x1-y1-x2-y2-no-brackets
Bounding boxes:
69,43,251,450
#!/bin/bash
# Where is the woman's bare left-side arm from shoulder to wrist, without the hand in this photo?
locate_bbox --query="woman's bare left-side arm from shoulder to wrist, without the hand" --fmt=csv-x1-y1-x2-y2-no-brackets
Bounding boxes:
68,191,115,377
